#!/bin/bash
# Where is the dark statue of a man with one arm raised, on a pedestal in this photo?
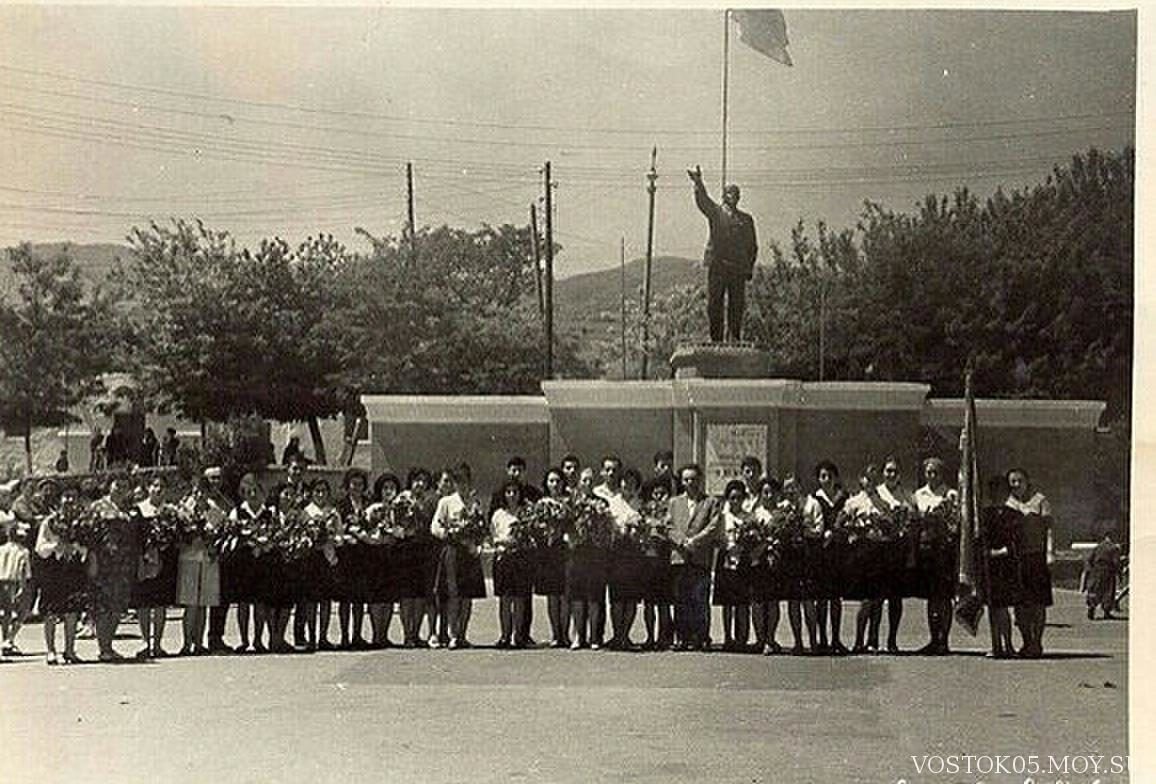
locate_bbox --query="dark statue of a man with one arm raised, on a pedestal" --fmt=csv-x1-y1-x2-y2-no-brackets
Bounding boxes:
687,167,758,342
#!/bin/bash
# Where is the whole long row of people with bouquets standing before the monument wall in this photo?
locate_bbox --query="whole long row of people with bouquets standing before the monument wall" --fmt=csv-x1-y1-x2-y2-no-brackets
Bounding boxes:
0,452,1052,665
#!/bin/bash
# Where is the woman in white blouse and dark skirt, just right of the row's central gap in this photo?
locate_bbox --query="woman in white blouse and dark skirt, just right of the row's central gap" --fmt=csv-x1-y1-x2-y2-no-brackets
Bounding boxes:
490,480,534,648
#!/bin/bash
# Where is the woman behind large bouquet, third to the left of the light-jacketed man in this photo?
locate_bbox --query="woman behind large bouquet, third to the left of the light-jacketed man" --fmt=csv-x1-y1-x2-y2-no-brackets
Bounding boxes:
566,467,609,650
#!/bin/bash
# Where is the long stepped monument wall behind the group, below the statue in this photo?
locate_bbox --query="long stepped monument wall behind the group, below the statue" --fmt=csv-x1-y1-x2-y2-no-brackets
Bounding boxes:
362,378,1105,547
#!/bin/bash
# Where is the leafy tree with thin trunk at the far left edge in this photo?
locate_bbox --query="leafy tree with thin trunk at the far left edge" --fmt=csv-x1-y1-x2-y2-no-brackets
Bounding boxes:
0,244,116,473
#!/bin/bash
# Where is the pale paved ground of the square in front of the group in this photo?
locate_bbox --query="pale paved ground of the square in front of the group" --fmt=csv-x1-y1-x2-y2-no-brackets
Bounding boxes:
0,592,1127,784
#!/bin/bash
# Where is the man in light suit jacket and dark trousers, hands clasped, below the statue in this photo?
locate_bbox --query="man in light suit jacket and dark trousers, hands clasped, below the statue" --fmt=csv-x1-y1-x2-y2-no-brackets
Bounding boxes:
670,465,719,650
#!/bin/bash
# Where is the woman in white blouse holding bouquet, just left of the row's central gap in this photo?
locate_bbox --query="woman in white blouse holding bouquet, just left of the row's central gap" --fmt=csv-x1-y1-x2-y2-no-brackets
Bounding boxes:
430,463,486,649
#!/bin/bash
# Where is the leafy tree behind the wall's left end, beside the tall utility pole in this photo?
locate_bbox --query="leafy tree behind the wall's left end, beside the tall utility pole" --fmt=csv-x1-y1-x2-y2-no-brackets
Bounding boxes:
323,224,592,394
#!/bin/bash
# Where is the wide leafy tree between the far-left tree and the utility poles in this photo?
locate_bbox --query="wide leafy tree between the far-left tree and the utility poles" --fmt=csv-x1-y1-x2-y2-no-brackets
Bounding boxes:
117,221,349,463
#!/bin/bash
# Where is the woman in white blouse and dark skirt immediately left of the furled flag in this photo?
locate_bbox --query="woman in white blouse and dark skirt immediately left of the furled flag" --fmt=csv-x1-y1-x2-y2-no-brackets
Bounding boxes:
911,457,959,656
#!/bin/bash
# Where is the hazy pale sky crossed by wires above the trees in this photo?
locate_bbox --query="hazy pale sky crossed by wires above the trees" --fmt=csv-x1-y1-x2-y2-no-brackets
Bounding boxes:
0,6,1136,276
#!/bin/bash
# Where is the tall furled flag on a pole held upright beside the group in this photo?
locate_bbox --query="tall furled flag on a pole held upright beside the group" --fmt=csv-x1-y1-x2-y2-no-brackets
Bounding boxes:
955,370,986,637
